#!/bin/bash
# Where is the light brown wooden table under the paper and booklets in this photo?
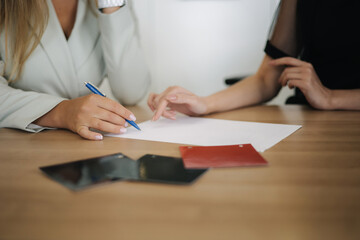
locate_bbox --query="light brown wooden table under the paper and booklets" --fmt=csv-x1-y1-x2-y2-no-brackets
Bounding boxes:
0,106,360,240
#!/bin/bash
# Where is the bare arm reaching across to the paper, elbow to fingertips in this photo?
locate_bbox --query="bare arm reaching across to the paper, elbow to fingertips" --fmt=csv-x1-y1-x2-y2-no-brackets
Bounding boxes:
148,55,283,121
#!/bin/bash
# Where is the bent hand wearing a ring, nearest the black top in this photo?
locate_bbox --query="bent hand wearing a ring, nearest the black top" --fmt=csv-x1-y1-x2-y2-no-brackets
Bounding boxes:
270,57,331,109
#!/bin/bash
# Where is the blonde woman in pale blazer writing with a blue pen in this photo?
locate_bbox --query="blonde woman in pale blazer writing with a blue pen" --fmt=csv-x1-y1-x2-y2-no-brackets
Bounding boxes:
0,0,150,140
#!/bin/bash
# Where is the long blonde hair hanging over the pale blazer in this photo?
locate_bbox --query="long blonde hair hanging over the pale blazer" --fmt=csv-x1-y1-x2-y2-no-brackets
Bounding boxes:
0,0,49,82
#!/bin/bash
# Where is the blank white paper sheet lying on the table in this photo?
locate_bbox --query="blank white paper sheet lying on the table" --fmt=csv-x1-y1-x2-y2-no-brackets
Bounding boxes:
107,116,301,152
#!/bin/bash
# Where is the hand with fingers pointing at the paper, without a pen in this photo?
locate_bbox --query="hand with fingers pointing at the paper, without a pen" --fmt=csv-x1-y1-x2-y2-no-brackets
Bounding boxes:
147,86,207,121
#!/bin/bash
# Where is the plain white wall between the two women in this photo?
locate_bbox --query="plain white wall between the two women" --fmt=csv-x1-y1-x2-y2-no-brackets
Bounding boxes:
101,0,289,103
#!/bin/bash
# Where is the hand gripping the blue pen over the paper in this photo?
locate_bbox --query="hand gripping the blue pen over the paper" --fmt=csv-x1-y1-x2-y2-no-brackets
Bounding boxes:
34,94,136,140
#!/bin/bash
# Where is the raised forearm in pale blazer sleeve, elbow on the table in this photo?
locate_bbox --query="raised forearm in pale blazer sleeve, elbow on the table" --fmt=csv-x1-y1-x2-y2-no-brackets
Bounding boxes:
99,2,150,105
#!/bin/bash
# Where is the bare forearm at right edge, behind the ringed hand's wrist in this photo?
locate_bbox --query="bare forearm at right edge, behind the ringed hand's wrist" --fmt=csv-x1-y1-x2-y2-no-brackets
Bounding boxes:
328,89,360,110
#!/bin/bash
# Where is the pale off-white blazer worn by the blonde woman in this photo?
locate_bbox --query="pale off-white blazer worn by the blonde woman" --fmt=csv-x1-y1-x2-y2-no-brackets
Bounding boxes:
0,0,150,132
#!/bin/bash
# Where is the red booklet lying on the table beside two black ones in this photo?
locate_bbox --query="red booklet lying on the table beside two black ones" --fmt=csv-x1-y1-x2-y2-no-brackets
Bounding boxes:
180,144,268,168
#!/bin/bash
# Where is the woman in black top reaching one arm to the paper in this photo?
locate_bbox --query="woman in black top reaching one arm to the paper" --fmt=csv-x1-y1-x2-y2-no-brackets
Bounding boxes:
148,0,360,120
